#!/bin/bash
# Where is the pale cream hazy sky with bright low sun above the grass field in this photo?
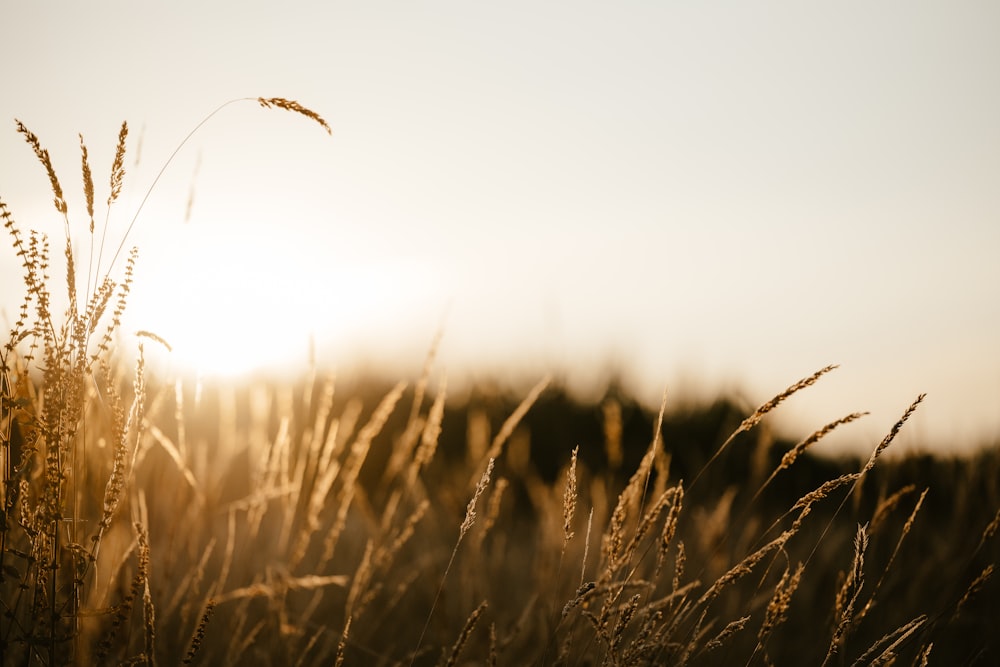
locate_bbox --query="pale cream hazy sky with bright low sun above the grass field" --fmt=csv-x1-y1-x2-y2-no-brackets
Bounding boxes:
0,0,1000,451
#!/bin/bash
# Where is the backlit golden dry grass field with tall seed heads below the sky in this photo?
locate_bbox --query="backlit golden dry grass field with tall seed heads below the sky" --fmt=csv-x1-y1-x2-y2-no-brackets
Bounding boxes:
0,104,1000,665
